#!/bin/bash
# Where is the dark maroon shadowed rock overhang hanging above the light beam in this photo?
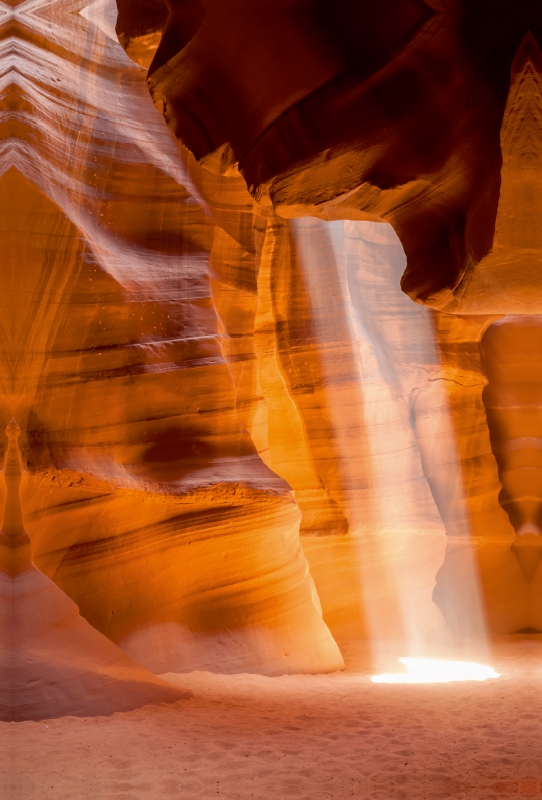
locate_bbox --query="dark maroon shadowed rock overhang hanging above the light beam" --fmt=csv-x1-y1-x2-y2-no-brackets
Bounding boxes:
137,0,542,310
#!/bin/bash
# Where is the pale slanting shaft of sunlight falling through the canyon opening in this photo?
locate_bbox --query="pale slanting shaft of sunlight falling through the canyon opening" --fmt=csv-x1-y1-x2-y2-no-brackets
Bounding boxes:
290,218,492,655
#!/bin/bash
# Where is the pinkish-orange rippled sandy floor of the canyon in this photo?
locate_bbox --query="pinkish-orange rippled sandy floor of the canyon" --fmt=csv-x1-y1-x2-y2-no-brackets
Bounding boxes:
0,637,542,800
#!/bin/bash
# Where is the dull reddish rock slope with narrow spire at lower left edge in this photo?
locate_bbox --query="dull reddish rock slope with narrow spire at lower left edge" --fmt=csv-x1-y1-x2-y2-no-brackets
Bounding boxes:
0,420,190,721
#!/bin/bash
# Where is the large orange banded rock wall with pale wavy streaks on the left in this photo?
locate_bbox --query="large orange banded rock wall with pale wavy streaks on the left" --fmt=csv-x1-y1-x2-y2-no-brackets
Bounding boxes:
0,0,343,674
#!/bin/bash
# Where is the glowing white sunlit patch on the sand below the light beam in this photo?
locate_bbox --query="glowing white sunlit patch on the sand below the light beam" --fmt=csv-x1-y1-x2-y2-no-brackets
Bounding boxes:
371,658,499,683
